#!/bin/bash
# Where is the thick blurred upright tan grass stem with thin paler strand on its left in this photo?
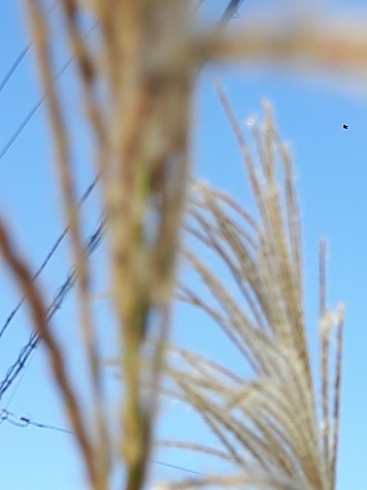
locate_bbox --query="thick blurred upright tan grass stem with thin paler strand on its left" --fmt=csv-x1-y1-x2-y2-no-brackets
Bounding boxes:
20,0,194,490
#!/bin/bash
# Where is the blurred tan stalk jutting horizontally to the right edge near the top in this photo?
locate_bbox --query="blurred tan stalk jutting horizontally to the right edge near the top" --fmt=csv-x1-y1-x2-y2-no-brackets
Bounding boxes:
204,12,367,76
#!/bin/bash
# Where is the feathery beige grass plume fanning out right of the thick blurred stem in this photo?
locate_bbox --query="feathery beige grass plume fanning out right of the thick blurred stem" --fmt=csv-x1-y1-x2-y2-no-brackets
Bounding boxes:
161,89,343,490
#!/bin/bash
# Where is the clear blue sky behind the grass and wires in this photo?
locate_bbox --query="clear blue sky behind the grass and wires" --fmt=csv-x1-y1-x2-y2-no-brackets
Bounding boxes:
0,0,367,490
